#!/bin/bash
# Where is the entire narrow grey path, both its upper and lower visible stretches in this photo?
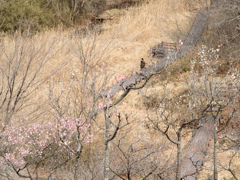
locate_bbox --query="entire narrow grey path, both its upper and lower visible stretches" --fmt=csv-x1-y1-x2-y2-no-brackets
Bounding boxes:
101,4,214,180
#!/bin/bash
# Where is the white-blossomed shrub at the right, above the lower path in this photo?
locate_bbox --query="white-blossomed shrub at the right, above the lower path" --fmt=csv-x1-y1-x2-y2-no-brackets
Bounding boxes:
187,45,240,116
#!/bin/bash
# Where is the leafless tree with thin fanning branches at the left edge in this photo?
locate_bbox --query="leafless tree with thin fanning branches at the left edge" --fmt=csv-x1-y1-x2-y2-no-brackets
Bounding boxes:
0,33,61,125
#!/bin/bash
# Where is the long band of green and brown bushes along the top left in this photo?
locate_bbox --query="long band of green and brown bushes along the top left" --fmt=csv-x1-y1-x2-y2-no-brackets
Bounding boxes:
0,0,106,33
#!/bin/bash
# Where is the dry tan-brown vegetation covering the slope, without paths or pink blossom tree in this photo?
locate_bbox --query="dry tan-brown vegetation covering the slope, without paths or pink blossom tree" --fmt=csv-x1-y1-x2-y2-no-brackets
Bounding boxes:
0,0,240,179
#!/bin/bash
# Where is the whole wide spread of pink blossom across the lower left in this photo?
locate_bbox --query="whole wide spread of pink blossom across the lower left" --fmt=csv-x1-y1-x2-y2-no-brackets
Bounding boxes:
0,118,93,168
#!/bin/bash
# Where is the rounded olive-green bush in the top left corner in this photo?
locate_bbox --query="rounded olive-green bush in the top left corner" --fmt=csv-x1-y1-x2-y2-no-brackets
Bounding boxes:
0,0,52,32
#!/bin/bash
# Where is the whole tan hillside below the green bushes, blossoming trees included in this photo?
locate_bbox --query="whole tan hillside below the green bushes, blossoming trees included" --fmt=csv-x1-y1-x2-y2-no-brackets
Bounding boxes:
0,0,240,179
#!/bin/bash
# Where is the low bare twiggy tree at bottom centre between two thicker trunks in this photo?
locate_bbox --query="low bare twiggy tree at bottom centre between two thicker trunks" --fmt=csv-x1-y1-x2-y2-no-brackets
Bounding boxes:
110,126,171,180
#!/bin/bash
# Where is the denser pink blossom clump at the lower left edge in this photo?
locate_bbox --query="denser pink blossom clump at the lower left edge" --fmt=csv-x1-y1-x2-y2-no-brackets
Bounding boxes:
0,122,56,167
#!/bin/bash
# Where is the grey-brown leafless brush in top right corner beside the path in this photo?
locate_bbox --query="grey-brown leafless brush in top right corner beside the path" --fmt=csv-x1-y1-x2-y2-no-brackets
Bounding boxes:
206,0,240,58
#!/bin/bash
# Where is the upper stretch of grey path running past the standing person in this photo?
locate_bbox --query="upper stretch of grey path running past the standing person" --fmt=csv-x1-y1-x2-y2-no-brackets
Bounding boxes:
100,8,209,97
